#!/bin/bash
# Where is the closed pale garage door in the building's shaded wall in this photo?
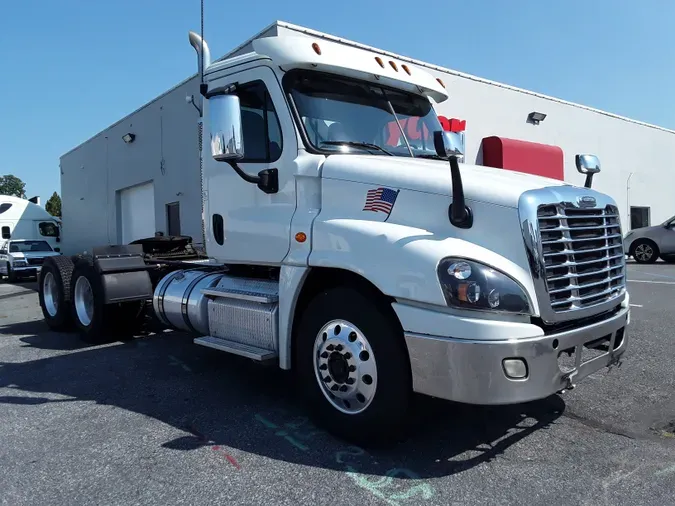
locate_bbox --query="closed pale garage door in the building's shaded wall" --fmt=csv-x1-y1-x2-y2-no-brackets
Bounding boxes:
120,182,156,244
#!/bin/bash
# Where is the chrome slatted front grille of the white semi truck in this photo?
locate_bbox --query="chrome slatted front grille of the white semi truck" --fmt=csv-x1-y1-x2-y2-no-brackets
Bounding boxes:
537,203,625,313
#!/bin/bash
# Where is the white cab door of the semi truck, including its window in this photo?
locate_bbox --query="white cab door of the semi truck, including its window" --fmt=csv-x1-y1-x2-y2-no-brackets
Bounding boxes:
203,66,298,265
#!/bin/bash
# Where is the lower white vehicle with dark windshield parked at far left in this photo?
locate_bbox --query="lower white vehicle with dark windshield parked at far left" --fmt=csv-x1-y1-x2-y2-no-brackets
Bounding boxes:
0,239,61,283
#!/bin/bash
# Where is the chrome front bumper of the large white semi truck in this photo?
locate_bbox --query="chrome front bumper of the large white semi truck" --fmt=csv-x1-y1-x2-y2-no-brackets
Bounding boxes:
405,307,630,404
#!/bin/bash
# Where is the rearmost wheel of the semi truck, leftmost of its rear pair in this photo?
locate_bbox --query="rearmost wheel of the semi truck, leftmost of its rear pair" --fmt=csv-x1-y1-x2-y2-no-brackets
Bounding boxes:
38,256,73,331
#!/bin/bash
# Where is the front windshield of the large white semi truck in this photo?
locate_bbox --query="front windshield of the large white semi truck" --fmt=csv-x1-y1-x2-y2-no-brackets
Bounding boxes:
289,71,442,156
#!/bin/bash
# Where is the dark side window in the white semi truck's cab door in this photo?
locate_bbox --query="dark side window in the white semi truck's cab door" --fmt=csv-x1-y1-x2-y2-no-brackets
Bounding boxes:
237,81,283,163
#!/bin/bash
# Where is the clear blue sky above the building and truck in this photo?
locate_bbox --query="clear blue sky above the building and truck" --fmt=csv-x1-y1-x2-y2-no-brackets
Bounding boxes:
0,0,675,203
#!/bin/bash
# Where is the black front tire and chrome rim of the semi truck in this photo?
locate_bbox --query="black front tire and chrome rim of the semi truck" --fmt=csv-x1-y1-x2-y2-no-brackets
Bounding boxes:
295,287,412,446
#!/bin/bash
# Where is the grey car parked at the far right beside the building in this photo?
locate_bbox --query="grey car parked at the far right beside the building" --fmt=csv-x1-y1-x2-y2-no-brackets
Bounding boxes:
623,216,675,264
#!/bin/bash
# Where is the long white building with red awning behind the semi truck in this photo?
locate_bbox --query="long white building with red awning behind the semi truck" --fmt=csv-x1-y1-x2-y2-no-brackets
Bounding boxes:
61,22,675,254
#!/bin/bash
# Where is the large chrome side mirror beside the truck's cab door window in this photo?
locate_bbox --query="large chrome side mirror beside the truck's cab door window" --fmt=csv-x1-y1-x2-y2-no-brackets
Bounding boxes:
209,95,244,162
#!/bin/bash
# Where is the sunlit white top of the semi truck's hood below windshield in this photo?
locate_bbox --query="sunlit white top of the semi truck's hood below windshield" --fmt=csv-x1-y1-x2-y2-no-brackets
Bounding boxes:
322,154,569,208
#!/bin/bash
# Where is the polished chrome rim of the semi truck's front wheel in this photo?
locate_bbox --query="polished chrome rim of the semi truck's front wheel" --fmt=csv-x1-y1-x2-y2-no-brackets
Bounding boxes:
314,320,377,415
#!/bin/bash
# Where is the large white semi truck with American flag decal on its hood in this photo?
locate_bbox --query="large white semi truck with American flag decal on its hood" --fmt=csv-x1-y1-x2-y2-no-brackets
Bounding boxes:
39,32,629,443
